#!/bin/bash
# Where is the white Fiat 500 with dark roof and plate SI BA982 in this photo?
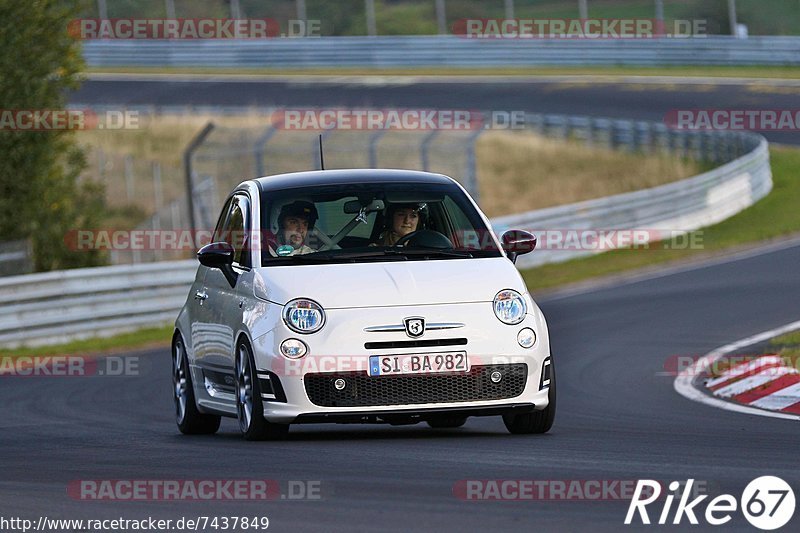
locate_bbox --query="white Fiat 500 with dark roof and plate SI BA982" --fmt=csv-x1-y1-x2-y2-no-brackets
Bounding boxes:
172,170,556,440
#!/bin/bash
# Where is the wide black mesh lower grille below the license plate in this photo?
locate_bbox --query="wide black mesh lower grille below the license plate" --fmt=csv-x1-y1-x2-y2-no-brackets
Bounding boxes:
304,363,528,407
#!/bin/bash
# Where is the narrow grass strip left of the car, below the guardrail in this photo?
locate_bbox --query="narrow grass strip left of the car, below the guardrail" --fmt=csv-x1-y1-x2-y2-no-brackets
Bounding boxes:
0,325,174,357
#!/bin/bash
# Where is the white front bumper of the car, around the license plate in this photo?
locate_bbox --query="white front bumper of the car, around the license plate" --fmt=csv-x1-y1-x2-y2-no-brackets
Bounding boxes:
253,303,550,423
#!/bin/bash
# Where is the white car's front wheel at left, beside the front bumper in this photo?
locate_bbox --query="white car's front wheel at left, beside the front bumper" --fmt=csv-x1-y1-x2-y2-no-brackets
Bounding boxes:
236,339,289,440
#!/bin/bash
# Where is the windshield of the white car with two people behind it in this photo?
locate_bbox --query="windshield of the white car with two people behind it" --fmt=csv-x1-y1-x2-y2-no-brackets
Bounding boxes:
261,182,502,266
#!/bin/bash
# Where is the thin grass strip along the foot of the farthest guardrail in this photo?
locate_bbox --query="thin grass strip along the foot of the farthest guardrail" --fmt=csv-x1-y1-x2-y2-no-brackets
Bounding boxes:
87,66,800,81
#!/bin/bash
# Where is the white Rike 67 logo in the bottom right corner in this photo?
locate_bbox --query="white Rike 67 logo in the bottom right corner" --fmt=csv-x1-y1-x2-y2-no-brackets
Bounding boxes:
625,476,795,530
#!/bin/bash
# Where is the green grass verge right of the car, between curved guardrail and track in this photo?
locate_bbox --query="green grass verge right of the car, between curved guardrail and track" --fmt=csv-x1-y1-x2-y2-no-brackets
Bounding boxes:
522,147,800,291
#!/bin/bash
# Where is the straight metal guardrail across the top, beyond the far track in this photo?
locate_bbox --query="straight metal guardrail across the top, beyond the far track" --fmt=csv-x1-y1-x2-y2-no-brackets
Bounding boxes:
83,35,800,69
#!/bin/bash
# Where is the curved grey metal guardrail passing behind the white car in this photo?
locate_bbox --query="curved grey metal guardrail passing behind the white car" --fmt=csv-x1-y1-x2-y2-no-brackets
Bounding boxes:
0,125,772,347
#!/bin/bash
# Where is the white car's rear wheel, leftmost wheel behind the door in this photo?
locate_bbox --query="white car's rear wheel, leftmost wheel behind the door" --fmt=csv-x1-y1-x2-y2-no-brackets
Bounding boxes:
172,333,221,435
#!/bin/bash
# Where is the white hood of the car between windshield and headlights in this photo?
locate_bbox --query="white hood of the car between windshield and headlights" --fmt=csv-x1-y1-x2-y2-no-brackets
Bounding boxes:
256,257,527,309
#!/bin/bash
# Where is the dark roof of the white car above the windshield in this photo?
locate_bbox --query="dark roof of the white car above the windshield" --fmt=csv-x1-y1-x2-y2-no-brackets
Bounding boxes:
253,168,455,193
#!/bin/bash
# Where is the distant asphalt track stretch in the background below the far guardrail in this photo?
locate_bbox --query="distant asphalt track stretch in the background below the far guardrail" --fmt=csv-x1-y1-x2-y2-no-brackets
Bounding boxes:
70,75,800,144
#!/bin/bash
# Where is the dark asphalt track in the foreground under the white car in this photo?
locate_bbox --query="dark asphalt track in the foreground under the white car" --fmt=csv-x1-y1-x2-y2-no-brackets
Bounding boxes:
0,240,800,532
